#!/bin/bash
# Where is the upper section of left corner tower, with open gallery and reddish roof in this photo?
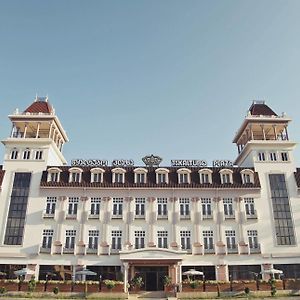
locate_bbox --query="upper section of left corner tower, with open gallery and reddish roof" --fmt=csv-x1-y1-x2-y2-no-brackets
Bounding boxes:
2,97,68,169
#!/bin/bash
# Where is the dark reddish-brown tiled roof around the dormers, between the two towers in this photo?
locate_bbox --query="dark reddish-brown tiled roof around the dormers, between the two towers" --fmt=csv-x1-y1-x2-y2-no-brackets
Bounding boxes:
41,166,260,188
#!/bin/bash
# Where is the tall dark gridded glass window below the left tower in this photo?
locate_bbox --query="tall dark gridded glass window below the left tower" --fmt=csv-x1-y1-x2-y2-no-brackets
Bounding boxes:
4,173,31,245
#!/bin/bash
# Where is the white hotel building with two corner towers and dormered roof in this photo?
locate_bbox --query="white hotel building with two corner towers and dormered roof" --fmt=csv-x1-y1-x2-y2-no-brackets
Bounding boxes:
0,98,300,290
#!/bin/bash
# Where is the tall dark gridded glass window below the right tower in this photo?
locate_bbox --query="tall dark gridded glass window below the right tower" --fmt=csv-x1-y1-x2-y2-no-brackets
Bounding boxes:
269,174,296,245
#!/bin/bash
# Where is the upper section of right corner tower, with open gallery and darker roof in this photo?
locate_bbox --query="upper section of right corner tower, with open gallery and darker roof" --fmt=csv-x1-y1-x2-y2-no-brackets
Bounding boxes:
233,101,296,167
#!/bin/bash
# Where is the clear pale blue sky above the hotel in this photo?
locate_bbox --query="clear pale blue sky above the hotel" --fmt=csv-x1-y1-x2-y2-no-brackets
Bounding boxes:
0,0,300,165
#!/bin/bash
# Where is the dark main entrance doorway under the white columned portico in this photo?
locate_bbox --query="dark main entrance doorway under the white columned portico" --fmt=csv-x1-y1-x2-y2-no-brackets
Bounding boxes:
135,266,169,291
